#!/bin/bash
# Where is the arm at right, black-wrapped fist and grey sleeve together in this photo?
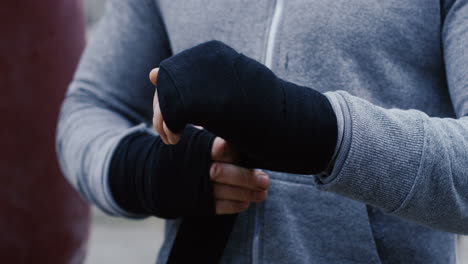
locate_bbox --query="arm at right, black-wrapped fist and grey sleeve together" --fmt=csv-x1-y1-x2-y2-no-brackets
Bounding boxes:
157,39,468,232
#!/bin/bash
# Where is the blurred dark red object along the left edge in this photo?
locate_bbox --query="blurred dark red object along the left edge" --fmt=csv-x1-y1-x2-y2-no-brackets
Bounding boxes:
0,0,89,263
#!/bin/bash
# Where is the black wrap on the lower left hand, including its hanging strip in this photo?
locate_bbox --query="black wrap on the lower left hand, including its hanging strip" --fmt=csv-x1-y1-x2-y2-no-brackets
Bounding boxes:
109,126,236,264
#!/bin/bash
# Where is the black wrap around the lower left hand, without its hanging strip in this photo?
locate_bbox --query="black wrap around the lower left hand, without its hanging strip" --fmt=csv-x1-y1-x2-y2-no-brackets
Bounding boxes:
109,126,215,218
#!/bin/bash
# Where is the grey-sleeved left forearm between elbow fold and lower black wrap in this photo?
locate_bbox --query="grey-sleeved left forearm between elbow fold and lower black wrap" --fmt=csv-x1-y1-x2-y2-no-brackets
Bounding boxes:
56,91,146,217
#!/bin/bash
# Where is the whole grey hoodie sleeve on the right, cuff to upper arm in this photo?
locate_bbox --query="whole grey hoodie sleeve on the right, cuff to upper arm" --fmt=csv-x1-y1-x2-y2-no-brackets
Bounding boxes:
316,0,468,234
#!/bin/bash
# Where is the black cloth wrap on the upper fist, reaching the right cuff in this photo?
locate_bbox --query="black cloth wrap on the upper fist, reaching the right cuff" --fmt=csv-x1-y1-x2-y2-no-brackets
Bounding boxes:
156,41,338,174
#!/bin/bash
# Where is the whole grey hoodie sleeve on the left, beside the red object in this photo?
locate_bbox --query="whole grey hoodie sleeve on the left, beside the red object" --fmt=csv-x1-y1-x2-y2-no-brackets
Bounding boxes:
56,0,170,217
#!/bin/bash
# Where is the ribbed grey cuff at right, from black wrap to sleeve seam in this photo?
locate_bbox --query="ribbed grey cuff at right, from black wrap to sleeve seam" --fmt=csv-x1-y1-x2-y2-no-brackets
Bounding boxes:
316,91,424,212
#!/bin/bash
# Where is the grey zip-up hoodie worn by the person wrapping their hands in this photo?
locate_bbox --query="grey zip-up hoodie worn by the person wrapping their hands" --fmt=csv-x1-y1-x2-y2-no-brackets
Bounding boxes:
57,0,468,263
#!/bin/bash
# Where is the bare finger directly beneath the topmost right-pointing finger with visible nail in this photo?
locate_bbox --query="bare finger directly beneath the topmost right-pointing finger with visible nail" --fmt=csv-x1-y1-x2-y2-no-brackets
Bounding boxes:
213,183,267,202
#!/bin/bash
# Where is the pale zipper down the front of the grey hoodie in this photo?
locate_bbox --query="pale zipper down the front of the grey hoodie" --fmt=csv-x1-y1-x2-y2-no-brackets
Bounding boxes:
252,0,284,264
